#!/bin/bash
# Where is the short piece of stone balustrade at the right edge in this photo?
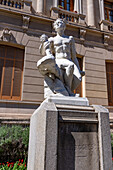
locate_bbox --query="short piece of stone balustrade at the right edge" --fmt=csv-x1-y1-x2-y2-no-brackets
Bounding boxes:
100,20,113,31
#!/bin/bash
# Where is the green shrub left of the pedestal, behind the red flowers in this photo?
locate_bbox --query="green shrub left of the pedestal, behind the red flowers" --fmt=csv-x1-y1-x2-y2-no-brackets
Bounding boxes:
0,125,29,163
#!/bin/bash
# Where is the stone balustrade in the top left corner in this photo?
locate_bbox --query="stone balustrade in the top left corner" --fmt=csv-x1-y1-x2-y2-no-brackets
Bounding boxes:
0,0,31,11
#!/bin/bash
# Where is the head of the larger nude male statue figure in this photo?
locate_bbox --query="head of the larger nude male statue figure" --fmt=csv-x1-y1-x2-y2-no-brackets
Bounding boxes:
53,18,67,31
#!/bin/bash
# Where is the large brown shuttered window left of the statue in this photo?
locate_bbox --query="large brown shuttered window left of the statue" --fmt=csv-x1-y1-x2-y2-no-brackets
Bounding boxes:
0,45,24,100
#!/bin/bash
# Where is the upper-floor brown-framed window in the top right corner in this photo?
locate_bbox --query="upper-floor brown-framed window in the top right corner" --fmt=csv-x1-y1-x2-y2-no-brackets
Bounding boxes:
104,1,113,22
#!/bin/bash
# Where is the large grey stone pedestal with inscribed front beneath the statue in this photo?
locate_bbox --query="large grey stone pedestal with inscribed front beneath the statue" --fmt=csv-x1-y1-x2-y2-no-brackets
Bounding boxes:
28,97,112,170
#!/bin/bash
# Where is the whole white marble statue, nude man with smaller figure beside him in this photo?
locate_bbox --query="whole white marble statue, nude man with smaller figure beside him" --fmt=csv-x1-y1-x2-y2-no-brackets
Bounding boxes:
37,18,85,96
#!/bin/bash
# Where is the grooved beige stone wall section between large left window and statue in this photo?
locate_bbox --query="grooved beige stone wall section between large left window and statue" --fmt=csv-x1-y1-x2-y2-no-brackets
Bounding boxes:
22,38,43,102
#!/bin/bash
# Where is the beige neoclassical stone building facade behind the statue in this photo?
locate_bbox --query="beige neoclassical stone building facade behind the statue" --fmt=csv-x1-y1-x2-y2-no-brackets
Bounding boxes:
0,0,113,123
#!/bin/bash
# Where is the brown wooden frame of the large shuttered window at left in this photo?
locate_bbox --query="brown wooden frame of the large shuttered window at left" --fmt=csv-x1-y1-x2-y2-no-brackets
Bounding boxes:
0,44,24,100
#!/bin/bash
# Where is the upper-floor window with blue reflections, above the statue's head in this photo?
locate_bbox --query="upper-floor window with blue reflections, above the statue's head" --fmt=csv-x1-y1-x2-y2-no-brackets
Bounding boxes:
59,0,74,11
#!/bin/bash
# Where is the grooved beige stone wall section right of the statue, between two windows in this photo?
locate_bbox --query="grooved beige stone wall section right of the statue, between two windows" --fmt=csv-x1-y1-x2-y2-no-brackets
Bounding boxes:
85,48,108,105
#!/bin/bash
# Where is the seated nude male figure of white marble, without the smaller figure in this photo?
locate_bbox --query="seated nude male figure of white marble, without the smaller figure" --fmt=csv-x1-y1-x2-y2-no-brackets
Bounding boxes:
48,18,84,91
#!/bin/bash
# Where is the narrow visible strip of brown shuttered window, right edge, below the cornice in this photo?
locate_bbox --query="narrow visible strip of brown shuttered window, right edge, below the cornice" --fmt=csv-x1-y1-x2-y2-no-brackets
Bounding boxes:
106,62,113,106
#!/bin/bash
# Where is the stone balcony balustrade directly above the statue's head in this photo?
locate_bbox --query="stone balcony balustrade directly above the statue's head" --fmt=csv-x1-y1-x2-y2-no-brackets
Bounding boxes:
50,7,86,24
